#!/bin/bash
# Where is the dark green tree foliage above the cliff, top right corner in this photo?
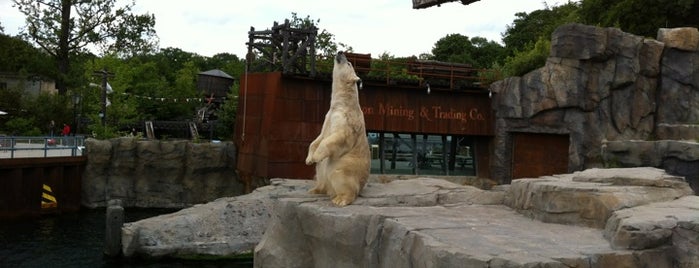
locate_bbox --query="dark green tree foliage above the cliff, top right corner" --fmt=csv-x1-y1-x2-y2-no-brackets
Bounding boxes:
580,0,699,38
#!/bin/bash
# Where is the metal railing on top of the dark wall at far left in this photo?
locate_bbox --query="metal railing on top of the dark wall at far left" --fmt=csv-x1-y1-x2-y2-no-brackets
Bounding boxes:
0,136,85,158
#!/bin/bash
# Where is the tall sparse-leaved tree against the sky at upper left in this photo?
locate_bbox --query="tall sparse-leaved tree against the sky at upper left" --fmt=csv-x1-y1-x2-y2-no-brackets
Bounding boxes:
14,0,157,94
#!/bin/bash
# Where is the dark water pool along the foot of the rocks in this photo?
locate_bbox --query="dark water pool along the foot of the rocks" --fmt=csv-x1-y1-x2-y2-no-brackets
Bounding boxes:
0,209,252,268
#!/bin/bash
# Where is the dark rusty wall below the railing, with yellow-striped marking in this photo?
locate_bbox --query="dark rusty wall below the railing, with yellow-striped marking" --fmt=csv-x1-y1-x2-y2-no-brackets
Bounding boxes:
0,156,87,219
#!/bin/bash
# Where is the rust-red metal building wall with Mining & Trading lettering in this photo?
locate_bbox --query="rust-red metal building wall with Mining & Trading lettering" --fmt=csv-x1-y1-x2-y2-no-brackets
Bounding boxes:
235,72,494,183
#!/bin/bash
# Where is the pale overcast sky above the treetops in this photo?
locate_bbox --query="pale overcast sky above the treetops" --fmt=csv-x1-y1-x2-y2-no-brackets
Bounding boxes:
0,0,563,58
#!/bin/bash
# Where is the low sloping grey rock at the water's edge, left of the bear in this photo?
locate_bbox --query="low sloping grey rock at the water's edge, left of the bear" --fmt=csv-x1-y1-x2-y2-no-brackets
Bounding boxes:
121,180,311,258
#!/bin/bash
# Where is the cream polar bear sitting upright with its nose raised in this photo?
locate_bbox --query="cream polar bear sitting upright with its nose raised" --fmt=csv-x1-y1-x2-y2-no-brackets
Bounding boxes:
306,51,371,207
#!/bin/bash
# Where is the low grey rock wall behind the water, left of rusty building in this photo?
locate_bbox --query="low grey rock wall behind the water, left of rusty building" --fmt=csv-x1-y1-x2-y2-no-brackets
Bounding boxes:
81,138,245,208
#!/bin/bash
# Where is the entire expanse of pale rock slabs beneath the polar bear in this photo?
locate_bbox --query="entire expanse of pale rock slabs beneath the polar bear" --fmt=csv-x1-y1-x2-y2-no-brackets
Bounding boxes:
122,168,699,268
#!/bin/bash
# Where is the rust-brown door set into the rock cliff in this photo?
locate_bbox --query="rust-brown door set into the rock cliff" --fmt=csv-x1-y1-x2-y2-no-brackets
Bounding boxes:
512,133,570,179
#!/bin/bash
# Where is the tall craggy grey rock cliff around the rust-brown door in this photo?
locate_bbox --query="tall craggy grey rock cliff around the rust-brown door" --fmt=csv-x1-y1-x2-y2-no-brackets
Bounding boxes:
490,24,699,182
